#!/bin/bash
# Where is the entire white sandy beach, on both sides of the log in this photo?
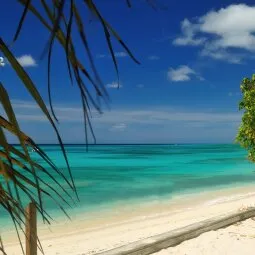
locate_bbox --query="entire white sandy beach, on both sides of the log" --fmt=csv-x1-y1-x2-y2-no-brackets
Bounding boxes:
2,186,255,255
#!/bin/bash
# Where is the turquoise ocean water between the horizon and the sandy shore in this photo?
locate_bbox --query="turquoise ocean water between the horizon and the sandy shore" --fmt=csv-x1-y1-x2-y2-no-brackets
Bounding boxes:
0,144,255,226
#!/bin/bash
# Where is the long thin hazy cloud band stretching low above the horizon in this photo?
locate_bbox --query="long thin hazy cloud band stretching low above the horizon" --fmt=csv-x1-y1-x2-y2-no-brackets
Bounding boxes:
9,100,241,124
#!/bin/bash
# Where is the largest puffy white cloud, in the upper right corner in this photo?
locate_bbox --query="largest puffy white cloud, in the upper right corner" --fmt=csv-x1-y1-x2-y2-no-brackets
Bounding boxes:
173,4,255,63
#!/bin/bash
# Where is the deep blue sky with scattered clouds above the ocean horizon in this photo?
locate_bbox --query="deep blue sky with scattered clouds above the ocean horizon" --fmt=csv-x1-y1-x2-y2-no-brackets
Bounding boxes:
0,0,255,143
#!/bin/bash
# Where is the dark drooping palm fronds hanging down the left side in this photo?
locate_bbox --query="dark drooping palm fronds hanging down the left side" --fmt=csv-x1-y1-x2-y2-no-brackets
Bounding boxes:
0,0,149,254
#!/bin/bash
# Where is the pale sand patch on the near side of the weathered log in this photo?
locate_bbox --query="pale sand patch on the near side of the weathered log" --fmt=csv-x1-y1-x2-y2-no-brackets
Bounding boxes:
154,219,255,255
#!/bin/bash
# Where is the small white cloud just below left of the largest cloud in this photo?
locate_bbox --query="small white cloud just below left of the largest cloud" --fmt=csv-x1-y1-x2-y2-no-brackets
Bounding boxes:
167,65,204,82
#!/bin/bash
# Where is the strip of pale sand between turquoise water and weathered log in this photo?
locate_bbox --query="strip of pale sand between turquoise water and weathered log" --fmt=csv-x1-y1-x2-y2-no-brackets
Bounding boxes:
2,185,255,255
